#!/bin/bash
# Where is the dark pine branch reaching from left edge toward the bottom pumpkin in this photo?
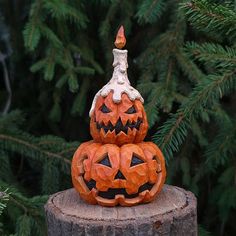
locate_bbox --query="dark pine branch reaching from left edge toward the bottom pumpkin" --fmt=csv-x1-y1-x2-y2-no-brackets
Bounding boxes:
0,111,78,177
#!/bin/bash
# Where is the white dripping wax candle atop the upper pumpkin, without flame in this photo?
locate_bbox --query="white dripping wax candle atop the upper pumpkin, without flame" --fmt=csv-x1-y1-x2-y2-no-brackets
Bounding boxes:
89,49,144,117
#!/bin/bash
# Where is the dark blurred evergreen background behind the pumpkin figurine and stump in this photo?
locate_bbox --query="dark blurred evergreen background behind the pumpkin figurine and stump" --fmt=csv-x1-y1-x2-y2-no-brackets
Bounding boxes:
0,0,236,236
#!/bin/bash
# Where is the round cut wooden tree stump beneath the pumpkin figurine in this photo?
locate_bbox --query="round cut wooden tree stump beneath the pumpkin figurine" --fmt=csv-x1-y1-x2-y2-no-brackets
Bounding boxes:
45,185,197,236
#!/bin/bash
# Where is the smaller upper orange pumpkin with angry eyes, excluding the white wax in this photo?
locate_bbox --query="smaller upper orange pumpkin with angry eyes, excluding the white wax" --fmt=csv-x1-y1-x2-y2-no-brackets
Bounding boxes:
90,92,148,146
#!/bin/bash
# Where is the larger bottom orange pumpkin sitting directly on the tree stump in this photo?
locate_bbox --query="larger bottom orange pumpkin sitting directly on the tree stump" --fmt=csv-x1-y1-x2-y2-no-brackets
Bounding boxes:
71,141,166,206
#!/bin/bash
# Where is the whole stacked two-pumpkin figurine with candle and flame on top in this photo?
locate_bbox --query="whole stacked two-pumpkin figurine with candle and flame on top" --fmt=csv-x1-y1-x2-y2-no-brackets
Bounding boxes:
71,26,166,206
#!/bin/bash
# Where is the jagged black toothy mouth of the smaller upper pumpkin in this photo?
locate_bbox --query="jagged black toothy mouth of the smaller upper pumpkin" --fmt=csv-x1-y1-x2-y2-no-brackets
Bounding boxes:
96,118,143,135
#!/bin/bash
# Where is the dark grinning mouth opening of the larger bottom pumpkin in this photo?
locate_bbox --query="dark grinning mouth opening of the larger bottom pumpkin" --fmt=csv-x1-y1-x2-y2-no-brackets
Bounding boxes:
85,179,154,199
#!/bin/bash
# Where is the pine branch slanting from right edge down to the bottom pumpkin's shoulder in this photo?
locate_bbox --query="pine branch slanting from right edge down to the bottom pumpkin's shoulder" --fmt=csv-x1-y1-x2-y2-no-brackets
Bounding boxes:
153,71,236,160
